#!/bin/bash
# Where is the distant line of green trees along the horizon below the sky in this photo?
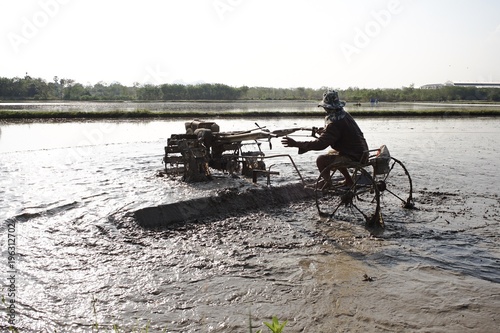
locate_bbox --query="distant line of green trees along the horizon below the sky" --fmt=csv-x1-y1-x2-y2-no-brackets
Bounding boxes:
0,75,500,103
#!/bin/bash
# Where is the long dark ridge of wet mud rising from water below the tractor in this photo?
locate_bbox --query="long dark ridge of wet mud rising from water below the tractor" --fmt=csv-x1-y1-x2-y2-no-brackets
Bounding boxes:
134,183,314,229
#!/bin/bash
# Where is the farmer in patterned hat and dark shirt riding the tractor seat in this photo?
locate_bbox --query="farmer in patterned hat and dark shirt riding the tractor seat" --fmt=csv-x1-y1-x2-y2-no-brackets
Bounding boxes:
281,90,368,188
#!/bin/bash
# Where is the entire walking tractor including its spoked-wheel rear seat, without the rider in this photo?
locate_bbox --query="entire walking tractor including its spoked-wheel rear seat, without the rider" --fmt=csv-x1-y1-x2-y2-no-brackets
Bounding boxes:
163,120,414,227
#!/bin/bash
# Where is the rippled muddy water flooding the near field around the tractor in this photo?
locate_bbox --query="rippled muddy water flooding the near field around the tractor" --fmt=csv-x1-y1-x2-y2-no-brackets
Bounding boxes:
0,118,500,332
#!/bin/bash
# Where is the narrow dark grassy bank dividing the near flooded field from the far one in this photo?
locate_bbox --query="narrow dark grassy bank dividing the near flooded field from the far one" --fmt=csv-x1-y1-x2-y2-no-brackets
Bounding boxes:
0,109,500,120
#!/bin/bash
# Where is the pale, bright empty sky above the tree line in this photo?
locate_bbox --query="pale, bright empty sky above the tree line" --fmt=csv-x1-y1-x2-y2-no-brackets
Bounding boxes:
0,0,500,89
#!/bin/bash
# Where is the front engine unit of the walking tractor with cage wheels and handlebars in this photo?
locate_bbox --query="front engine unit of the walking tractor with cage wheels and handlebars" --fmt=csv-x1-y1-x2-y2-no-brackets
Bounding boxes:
163,120,306,184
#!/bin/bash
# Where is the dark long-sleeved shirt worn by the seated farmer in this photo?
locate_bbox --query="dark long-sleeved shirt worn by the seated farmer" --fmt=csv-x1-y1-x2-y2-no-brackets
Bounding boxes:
297,112,368,161
